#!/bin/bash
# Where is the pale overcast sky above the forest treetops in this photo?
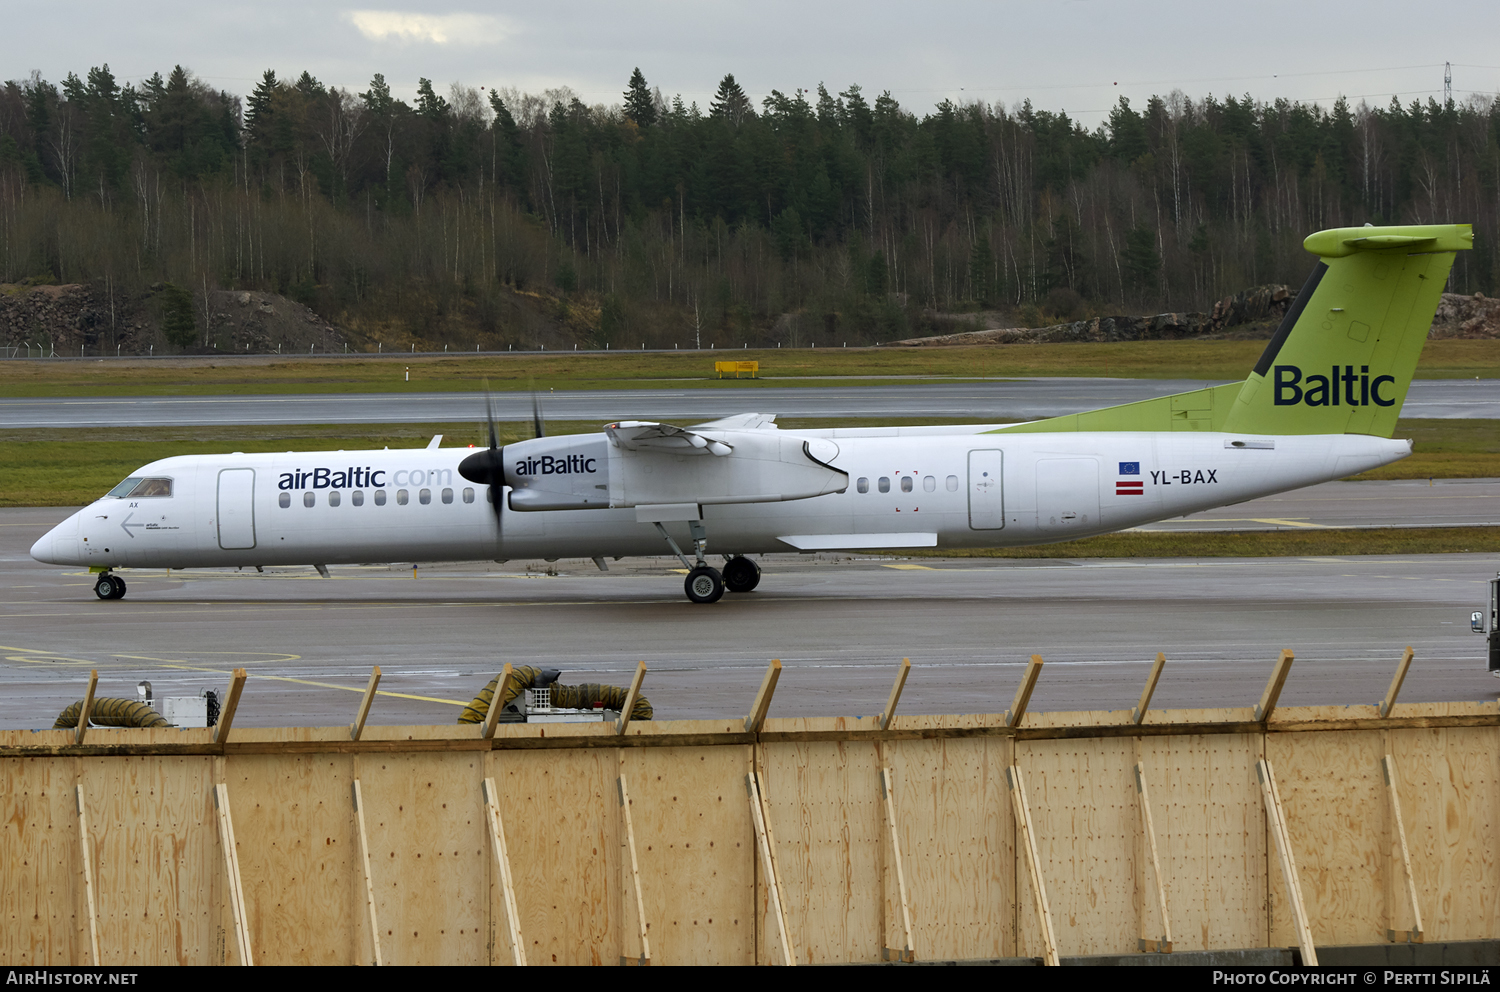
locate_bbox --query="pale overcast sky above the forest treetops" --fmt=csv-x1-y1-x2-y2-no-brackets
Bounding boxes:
11,0,1500,128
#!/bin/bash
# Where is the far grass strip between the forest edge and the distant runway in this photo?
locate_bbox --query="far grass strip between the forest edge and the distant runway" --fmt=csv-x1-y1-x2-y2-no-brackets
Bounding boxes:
0,341,1500,398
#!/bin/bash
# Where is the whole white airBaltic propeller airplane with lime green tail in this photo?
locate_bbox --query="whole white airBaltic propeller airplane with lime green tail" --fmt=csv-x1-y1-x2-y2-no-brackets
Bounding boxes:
32,225,1473,603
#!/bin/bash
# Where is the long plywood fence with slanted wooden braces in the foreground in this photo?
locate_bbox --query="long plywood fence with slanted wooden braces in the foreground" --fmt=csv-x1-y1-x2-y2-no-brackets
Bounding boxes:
0,651,1500,965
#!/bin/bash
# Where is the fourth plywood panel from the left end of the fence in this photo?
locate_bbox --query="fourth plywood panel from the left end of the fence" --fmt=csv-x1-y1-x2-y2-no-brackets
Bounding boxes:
357,752,486,965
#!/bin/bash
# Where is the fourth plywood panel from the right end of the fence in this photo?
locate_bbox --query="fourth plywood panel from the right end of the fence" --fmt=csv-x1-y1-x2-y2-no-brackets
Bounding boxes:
1016,738,1140,957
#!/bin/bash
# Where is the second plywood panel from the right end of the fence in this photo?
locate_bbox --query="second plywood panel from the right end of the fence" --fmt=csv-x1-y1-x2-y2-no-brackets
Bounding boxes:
1266,731,1395,945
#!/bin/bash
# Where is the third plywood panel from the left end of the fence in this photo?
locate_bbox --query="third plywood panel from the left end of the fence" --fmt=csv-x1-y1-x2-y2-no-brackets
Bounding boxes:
224,755,358,965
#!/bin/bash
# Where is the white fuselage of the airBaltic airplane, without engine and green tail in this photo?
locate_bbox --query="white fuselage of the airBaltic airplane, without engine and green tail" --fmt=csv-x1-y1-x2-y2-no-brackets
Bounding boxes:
32,428,1412,569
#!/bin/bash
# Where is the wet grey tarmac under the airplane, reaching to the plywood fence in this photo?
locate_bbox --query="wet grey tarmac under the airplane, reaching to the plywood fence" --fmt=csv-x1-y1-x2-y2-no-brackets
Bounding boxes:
0,480,1500,728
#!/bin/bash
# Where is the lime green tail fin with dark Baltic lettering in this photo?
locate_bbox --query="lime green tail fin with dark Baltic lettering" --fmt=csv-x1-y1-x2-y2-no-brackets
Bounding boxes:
1223,224,1475,437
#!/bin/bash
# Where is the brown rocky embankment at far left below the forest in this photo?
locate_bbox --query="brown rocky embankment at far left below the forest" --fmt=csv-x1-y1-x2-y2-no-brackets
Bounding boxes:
0,284,345,357
